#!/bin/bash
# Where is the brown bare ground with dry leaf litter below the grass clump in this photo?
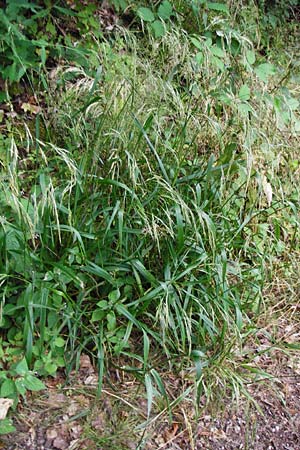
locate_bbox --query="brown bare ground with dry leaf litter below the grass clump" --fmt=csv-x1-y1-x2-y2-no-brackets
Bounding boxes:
0,352,300,450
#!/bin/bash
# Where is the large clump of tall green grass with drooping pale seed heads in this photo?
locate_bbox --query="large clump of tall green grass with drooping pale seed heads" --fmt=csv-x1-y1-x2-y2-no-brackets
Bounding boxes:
0,3,299,426
